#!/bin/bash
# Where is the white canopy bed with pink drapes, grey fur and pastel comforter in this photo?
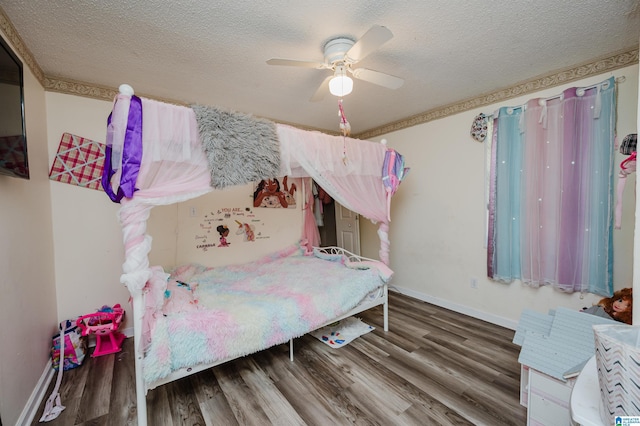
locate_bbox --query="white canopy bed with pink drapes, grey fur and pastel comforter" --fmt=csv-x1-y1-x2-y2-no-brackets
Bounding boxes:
102,85,406,425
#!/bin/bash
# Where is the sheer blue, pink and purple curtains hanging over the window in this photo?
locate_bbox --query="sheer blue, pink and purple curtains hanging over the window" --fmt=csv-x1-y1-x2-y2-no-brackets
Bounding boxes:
487,77,616,296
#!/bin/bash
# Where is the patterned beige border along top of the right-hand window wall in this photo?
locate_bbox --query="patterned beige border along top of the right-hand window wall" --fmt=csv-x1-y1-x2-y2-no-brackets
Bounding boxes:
355,46,638,139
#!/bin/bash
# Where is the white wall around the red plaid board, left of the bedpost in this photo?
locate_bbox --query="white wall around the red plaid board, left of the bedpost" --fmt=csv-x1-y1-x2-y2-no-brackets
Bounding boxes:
46,92,131,327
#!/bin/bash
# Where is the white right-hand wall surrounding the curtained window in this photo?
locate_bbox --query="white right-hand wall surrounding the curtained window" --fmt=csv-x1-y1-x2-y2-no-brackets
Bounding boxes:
362,65,638,328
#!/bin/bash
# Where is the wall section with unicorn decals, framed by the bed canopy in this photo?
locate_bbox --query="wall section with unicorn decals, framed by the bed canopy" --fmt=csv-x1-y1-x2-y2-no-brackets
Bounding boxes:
147,181,302,270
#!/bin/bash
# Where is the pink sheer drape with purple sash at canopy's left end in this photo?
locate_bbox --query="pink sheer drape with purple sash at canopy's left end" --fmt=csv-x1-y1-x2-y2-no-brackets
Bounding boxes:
103,94,212,294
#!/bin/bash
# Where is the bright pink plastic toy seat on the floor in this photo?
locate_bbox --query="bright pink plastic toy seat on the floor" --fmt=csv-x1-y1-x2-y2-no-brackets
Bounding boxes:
76,304,125,357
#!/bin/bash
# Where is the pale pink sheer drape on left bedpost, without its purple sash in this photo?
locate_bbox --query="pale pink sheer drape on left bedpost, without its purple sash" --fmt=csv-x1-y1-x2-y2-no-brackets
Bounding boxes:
107,95,211,293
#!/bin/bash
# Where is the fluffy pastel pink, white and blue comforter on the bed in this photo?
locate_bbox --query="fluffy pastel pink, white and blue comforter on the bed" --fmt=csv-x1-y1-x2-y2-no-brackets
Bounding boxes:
144,246,392,383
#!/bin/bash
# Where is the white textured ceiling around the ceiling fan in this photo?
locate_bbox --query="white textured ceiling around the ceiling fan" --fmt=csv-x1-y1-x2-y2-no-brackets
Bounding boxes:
0,0,640,134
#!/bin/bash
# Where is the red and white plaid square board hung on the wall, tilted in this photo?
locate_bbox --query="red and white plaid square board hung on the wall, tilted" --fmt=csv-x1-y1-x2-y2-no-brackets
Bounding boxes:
49,133,105,191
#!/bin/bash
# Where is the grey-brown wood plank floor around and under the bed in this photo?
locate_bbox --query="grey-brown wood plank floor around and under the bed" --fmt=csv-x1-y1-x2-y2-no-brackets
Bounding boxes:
33,292,526,426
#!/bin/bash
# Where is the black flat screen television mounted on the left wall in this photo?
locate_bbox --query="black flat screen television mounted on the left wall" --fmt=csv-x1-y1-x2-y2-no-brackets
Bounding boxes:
0,37,29,179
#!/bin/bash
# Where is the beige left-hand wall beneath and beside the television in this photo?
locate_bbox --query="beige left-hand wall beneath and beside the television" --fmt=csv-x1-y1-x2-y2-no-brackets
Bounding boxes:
0,30,57,425
